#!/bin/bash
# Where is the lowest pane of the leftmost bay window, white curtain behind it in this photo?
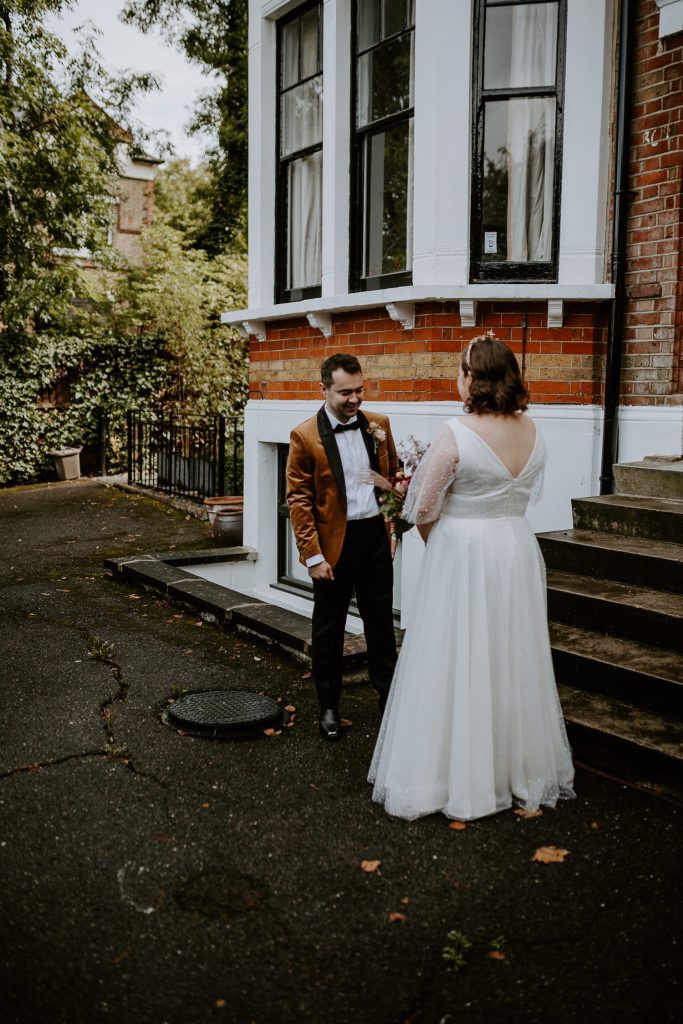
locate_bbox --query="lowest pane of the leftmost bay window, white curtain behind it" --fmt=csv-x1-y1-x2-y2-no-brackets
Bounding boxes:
287,152,323,289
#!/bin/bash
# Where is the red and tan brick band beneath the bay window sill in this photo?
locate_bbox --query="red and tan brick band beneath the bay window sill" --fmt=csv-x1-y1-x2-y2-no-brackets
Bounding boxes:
250,303,607,404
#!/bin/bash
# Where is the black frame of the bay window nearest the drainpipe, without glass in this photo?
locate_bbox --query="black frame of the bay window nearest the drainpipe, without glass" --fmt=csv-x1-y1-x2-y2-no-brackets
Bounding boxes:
470,0,566,284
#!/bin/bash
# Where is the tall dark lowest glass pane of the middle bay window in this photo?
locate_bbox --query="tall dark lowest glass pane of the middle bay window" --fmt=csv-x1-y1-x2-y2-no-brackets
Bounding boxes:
364,119,413,278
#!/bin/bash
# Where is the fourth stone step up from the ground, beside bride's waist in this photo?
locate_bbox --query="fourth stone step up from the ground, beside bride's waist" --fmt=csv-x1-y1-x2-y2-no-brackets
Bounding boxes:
538,529,683,594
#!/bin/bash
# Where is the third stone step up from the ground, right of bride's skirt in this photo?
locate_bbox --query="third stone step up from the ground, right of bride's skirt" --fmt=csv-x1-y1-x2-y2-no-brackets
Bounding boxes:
548,569,683,651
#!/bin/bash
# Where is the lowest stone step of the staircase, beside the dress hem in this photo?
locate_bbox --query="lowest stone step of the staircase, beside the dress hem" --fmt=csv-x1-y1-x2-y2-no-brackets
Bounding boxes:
558,684,683,797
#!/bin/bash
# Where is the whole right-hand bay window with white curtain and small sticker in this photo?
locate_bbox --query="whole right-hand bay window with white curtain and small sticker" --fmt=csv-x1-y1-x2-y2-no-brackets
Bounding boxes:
471,0,565,281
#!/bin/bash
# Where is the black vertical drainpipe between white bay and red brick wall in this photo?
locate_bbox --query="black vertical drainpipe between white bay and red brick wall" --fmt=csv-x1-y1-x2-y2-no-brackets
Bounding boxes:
600,0,634,495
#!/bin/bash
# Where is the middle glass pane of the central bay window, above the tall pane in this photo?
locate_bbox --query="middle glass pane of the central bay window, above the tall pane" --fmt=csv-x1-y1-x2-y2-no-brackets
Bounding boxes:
356,32,414,127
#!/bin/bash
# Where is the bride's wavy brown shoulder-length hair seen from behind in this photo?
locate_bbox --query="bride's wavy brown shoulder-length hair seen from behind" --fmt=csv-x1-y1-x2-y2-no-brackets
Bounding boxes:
462,334,528,414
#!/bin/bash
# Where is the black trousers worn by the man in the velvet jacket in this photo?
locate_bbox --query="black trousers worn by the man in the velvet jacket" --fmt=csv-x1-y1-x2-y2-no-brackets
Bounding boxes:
311,515,396,709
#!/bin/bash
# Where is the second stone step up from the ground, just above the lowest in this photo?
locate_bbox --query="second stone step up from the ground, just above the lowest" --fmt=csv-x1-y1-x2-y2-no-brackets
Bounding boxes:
549,622,683,721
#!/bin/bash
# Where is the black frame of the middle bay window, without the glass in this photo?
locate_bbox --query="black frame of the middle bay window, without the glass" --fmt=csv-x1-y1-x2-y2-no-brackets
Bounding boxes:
349,0,417,292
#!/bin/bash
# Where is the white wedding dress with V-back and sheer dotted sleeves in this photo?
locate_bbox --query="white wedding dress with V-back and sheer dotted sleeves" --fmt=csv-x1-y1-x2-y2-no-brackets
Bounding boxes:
369,419,574,820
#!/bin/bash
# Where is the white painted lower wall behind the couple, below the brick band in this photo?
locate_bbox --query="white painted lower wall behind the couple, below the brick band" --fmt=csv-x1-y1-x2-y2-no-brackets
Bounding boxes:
187,400,683,632
